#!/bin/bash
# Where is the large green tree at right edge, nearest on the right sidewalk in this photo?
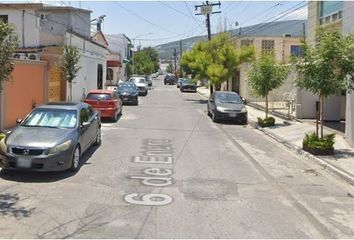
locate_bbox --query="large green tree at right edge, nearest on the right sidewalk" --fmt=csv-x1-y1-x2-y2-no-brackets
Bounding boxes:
294,29,354,138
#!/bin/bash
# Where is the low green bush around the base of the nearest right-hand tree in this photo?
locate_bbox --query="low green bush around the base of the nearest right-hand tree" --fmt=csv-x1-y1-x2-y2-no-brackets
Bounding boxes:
302,133,336,150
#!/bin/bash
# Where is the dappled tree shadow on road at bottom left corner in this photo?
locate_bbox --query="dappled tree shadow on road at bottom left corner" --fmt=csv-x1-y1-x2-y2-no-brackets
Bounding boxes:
0,193,35,218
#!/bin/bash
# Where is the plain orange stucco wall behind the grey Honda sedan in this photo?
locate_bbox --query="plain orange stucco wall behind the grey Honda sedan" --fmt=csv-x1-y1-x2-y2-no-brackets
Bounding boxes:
3,60,47,129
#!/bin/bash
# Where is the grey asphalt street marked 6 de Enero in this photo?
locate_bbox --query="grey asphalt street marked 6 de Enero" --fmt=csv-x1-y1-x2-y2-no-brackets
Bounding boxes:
0,76,354,238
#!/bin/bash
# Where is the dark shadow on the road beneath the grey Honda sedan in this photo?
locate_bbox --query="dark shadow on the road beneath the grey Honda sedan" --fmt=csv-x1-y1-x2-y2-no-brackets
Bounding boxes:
0,146,98,183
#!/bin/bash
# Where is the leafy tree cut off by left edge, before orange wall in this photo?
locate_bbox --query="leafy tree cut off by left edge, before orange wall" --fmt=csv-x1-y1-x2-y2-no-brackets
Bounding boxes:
0,21,18,93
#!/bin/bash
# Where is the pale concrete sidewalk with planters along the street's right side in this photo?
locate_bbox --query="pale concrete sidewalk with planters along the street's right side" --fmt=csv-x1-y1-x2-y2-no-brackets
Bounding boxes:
197,87,354,185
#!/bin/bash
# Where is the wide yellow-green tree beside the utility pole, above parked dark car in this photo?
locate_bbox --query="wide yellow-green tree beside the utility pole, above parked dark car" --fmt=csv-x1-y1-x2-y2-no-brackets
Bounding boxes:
181,33,254,93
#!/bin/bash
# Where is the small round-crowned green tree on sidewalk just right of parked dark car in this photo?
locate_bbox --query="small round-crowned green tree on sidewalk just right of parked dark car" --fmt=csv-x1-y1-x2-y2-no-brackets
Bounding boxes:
248,52,289,118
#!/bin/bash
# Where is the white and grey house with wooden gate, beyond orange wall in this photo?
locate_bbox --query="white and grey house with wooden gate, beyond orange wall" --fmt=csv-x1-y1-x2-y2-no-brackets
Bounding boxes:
0,3,108,101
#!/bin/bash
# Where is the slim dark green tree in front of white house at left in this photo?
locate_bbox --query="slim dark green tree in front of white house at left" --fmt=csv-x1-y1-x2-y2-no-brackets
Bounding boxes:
61,46,81,101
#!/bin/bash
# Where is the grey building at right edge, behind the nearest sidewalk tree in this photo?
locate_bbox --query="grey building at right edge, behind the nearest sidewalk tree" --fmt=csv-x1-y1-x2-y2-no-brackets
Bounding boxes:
302,1,354,146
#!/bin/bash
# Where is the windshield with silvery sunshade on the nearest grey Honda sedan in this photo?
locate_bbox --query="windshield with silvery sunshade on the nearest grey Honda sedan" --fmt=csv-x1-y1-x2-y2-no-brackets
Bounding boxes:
21,108,77,128
